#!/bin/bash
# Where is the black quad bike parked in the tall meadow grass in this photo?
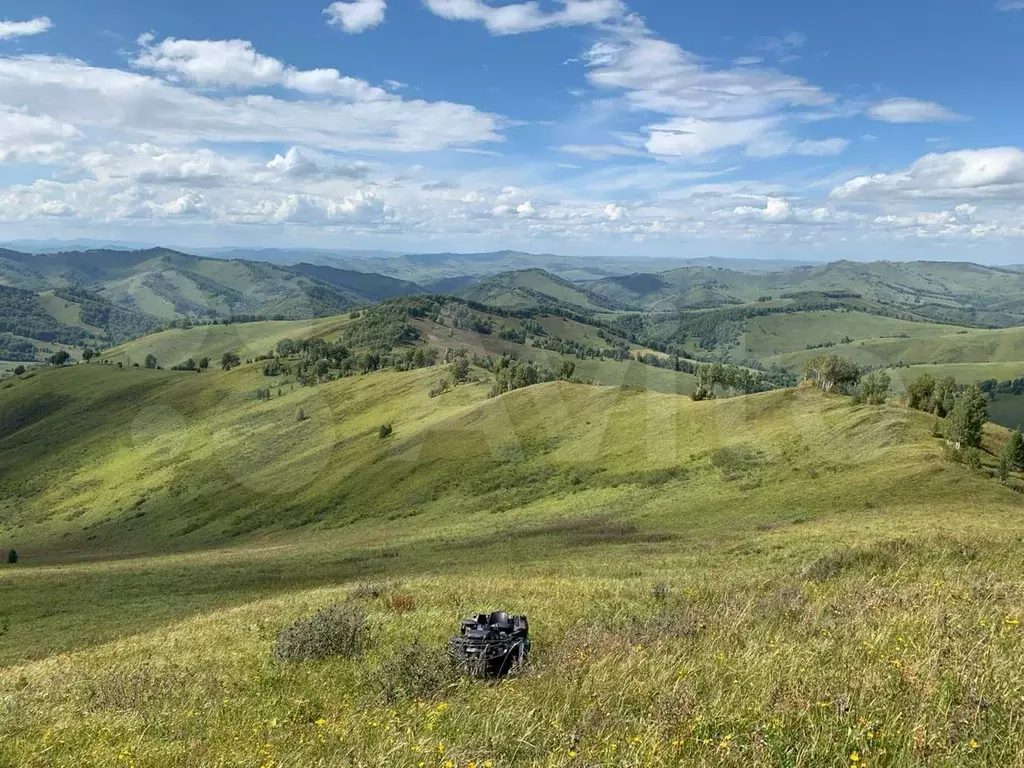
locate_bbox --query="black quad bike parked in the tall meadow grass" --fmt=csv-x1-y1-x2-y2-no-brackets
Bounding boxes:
449,610,529,677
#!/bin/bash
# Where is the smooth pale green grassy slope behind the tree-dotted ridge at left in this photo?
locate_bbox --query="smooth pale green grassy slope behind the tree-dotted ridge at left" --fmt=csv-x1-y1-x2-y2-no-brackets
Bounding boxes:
101,316,349,368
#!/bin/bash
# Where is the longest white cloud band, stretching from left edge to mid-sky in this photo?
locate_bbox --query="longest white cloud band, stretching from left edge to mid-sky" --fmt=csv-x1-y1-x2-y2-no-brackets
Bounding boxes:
0,56,506,152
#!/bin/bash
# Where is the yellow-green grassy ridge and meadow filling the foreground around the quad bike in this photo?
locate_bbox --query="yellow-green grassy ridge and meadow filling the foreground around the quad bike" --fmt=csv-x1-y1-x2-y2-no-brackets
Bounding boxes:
0,367,1024,768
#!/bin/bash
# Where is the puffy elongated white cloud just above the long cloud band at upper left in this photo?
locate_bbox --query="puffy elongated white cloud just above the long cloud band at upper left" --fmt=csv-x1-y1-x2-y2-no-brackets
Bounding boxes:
134,35,392,101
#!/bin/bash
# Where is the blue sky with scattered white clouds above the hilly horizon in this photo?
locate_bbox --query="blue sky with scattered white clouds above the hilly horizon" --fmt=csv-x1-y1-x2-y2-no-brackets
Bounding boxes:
0,0,1024,263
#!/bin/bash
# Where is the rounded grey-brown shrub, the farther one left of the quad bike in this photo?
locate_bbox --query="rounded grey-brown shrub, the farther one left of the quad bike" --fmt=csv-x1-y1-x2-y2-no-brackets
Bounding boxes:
273,603,371,662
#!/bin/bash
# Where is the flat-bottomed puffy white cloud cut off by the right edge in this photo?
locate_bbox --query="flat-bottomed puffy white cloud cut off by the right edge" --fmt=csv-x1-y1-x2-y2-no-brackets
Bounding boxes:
831,146,1024,200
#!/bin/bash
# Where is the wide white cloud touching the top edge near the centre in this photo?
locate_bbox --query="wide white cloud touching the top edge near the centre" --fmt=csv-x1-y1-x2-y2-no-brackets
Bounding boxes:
423,0,626,35
